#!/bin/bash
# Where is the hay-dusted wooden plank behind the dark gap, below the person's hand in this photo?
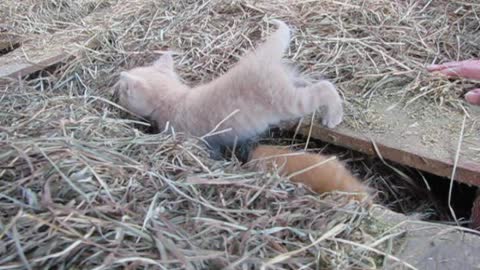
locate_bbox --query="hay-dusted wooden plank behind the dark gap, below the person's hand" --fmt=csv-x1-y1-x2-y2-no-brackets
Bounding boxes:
300,99,480,186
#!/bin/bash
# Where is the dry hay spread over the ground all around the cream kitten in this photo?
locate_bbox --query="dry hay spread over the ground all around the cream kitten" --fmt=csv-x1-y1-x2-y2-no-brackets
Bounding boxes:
0,0,480,269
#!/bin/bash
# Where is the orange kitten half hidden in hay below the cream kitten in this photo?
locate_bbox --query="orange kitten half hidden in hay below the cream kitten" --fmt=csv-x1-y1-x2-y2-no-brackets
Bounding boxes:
249,145,368,199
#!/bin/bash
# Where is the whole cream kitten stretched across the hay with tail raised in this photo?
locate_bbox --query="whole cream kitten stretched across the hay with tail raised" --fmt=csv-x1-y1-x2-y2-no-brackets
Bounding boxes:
117,20,343,147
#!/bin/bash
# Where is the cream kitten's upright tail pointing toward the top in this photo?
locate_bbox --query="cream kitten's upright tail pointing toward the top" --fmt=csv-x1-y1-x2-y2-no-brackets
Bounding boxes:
256,19,290,59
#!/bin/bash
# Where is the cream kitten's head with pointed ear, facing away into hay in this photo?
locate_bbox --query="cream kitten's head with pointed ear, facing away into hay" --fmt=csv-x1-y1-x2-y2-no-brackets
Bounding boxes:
114,53,181,117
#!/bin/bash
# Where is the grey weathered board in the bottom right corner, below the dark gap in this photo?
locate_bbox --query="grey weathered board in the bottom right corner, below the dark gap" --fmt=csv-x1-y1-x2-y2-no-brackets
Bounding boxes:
372,206,480,270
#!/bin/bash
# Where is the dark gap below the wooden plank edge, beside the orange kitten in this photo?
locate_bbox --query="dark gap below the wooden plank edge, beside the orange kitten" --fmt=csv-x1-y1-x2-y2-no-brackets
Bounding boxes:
263,129,477,226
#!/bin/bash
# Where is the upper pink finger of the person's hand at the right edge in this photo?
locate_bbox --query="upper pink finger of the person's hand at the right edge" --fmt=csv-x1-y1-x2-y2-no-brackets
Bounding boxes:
427,60,480,80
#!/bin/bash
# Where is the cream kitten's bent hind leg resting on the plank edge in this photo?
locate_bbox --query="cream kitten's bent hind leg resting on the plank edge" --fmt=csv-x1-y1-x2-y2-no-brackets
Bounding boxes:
290,80,343,128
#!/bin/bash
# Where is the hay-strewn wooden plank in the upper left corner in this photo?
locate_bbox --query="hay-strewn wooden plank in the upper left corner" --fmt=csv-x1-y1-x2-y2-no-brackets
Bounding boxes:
0,9,110,78
